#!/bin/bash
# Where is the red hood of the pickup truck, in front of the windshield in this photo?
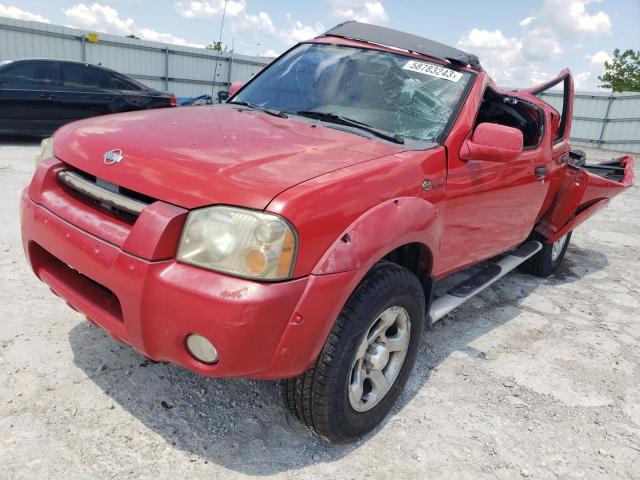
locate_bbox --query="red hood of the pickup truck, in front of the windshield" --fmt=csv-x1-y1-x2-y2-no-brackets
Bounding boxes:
54,105,402,209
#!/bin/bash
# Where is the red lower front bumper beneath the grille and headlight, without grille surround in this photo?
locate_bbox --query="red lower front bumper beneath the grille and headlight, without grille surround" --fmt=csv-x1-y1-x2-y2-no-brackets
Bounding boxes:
21,190,316,378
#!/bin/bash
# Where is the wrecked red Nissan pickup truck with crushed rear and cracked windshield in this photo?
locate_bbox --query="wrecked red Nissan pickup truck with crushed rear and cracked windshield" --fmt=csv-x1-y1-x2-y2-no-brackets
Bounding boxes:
21,22,633,442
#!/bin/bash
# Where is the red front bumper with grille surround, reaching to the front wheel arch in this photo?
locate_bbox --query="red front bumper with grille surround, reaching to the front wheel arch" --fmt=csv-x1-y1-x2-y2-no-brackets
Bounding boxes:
20,157,368,379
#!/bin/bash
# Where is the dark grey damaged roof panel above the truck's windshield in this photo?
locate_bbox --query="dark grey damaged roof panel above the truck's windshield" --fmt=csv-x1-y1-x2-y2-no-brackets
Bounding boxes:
324,21,480,68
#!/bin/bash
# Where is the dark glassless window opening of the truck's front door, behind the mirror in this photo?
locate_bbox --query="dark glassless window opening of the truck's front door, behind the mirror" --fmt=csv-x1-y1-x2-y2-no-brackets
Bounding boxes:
474,88,544,148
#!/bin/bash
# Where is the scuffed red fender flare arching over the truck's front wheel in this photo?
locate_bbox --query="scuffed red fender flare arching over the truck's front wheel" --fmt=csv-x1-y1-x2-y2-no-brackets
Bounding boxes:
257,197,442,379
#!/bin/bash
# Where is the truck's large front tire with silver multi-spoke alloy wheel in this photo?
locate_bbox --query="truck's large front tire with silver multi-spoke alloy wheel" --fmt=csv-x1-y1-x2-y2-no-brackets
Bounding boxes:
282,262,425,443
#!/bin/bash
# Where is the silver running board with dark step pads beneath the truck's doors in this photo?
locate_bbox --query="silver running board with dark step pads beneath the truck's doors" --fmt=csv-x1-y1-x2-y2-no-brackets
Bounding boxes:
429,240,542,324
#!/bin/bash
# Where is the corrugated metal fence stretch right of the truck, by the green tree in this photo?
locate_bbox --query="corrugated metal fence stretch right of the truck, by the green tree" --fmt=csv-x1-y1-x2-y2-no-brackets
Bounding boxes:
542,92,640,152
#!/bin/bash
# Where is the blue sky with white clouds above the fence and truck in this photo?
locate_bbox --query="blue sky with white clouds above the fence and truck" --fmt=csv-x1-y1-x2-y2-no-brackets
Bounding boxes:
0,0,640,91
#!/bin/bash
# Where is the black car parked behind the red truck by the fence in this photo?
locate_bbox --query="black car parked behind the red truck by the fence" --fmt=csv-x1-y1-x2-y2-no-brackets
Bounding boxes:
0,60,175,136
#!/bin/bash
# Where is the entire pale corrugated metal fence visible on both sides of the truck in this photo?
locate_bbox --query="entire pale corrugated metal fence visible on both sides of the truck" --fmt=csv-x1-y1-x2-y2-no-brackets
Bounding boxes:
0,18,640,152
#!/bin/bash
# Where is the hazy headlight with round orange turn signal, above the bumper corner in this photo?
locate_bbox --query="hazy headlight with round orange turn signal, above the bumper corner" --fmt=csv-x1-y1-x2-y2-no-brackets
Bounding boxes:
177,206,297,280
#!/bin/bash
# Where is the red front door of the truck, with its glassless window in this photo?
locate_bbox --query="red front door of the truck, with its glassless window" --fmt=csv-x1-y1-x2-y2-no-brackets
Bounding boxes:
436,83,549,275
